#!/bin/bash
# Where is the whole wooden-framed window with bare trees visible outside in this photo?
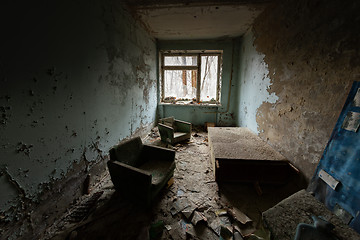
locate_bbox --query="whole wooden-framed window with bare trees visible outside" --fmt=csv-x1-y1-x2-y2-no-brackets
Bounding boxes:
160,51,222,104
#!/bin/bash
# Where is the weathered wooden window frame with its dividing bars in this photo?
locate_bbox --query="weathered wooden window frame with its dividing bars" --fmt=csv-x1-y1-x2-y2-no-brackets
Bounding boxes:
159,50,223,105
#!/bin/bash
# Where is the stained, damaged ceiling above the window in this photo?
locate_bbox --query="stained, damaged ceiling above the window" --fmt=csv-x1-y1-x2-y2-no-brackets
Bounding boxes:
128,0,268,40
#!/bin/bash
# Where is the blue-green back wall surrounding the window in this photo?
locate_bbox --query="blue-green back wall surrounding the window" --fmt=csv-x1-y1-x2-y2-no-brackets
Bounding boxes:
158,38,239,126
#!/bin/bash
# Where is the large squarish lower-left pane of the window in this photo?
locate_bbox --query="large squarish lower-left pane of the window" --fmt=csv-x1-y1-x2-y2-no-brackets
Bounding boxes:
164,70,197,102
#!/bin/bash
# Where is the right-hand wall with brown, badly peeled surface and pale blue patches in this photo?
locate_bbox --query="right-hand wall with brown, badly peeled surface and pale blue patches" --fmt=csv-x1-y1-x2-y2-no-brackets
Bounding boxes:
238,0,360,180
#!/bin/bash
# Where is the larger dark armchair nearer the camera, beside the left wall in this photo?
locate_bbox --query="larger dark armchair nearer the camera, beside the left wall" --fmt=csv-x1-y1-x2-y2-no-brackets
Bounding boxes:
107,137,175,206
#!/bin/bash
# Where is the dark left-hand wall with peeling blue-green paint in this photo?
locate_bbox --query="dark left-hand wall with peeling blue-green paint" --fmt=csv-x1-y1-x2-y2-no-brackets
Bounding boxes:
0,1,157,239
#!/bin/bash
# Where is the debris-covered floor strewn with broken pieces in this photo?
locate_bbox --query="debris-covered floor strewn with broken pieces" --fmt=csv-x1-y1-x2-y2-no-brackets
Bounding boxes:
44,128,300,240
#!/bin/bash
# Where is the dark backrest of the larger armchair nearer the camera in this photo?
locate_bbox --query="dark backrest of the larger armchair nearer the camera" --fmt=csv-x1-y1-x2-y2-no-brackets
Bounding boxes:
110,137,143,167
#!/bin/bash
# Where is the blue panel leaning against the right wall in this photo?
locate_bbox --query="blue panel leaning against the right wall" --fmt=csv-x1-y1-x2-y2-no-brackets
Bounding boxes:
309,82,360,232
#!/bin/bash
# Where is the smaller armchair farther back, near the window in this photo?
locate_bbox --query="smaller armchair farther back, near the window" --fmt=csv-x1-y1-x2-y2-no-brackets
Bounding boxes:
158,117,191,144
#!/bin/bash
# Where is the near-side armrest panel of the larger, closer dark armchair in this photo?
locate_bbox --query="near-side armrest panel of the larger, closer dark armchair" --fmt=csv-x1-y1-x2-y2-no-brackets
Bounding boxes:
107,160,152,194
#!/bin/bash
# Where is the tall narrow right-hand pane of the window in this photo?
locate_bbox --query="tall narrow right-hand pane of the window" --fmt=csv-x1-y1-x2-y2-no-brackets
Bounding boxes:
200,56,219,102
